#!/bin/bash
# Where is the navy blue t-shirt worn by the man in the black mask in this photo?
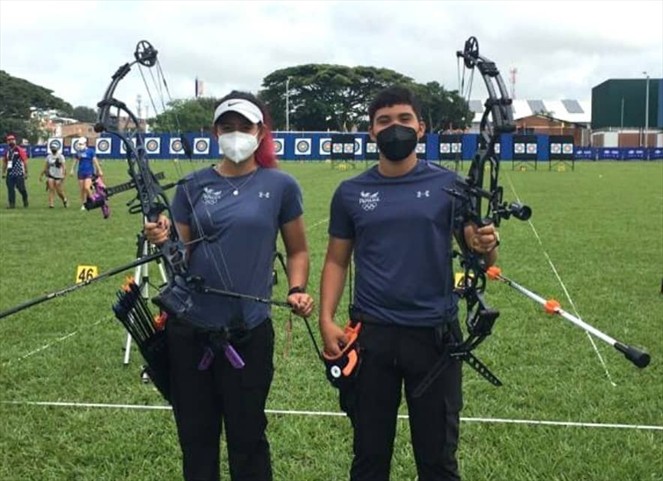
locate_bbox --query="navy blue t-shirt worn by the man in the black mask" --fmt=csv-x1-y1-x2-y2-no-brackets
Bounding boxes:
329,161,458,326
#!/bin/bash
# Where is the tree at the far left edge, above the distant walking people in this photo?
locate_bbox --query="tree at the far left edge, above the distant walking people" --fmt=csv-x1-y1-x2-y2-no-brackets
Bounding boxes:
0,70,72,138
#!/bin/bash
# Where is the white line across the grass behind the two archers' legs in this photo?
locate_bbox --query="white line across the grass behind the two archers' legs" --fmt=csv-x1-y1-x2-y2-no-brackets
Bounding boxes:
0,401,663,431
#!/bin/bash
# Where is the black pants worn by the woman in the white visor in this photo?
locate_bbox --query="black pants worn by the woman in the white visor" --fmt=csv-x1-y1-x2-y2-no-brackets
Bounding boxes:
168,320,274,481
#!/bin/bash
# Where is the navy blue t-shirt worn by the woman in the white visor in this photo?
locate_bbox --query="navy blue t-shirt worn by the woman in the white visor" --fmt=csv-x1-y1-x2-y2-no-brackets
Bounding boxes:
171,168,303,329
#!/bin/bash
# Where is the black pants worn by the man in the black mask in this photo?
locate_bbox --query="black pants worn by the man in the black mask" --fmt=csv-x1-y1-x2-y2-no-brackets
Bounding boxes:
341,323,462,481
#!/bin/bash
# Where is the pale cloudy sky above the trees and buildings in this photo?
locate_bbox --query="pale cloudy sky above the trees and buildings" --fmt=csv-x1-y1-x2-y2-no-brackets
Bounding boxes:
0,0,663,111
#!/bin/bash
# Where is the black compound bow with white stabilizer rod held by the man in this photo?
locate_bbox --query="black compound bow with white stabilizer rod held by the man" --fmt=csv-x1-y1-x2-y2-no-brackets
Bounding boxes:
415,37,649,396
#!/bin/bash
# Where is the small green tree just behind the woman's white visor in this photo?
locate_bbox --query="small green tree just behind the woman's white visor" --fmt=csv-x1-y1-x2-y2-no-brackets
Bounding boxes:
149,97,219,133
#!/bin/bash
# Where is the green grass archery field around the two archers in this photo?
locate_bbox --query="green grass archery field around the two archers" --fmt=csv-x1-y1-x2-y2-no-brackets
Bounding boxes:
0,161,663,481
